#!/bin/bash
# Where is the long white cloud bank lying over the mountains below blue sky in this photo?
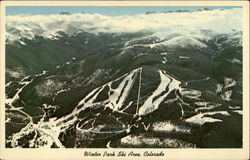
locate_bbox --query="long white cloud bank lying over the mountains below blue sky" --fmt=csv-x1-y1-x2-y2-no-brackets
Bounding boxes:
6,8,242,42
